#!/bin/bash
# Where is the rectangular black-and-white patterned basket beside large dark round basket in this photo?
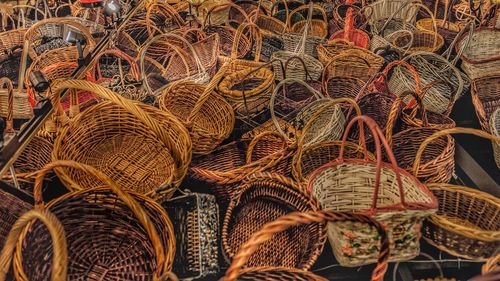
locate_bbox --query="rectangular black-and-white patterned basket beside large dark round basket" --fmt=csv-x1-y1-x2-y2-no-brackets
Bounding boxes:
162,190,220,279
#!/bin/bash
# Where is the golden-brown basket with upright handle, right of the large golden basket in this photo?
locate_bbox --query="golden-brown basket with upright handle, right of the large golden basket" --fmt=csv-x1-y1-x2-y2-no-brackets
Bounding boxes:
159,63,234,154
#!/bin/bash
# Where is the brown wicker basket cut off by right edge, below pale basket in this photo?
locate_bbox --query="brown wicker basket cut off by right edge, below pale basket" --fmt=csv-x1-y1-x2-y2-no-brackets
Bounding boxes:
471,75,500,132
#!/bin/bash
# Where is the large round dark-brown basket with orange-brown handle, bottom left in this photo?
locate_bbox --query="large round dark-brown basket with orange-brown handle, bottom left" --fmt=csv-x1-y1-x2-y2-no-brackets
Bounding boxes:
14,161,175,280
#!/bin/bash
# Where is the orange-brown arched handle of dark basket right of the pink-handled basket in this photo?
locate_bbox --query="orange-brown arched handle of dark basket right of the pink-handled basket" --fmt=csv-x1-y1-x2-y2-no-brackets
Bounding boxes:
385,91,429,147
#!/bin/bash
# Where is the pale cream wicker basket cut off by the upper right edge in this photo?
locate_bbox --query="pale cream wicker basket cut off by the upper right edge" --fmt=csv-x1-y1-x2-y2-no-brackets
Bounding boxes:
455,28,500,80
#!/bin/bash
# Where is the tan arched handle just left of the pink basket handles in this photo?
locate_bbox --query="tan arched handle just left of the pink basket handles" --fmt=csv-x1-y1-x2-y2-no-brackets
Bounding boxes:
298,98,364,149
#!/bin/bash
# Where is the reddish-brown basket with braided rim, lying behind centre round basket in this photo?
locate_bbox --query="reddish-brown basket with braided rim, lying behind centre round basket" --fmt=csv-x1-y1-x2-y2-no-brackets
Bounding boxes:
188,131,294,201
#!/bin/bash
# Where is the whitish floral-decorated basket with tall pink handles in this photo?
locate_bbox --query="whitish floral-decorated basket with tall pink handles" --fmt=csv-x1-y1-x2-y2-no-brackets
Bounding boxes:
308,116,437,266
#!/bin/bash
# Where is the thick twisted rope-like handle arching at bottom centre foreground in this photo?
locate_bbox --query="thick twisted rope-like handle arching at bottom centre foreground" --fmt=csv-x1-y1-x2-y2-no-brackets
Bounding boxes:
222,211,389,281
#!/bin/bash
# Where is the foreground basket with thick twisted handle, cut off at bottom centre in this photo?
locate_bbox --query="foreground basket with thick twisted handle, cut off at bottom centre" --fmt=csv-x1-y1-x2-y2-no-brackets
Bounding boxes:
222,211,389,281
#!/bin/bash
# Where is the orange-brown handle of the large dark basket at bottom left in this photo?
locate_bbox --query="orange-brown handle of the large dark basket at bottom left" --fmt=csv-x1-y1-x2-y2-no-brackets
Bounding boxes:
33,160,170,276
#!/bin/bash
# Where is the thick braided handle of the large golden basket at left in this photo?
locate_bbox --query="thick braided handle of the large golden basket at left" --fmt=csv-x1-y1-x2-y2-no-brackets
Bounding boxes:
51,80,191,192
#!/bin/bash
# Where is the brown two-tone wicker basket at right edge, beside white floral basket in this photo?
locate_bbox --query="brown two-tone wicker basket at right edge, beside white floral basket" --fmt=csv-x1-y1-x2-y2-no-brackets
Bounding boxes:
423,183,500,260
